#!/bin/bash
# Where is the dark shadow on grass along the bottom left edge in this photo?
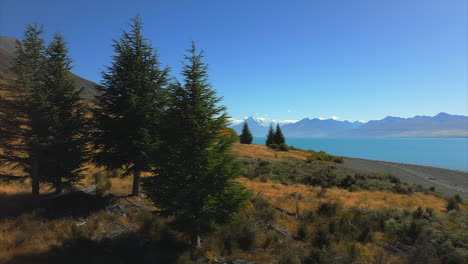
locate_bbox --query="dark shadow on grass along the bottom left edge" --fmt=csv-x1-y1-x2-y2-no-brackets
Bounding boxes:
6,231,187,264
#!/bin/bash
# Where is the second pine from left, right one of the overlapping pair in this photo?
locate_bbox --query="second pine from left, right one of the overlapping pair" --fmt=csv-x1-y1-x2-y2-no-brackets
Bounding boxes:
40,34,87,193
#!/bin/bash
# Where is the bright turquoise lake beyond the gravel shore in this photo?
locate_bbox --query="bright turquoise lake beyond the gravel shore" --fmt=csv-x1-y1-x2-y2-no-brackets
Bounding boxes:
253,138,468,171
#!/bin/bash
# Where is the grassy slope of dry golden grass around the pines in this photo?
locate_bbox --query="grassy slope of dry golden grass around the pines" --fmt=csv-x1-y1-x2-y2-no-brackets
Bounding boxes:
0,144,468,263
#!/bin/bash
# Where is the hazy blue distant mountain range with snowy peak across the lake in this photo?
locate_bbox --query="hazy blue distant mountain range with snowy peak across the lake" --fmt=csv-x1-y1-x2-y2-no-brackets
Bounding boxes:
231,113,468,138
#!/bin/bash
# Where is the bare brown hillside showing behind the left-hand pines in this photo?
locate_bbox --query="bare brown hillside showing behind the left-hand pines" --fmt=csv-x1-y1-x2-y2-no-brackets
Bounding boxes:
0,36,98,100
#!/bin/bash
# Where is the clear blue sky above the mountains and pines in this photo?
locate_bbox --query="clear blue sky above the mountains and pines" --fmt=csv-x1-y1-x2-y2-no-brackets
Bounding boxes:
0,0,468,120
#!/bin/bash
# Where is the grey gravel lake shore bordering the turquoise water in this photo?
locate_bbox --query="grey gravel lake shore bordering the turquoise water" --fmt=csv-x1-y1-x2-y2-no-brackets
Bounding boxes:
338,157,468,199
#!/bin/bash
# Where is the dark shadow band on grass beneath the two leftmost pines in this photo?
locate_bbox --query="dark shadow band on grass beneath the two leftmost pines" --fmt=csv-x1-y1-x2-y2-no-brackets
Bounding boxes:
0,192,112,220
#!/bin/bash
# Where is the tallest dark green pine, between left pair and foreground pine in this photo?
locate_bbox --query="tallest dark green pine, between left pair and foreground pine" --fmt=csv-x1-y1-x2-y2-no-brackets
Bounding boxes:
93,16,169,196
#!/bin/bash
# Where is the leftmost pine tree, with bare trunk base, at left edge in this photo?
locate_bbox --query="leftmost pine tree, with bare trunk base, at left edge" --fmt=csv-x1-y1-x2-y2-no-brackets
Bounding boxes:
0,24,47,207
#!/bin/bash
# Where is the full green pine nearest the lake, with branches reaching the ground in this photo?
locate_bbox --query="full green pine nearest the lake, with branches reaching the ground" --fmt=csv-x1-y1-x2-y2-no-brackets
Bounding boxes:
143,43,247,246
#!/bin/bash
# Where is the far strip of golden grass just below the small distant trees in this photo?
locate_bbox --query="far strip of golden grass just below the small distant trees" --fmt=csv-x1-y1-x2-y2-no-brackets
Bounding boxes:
232,143,308,161
